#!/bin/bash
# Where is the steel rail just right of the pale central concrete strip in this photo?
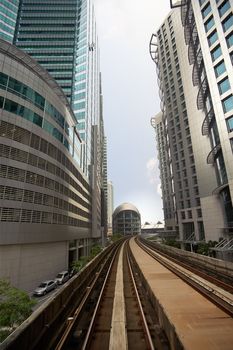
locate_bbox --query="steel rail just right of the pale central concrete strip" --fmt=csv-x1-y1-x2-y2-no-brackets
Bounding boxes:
127,245,155,350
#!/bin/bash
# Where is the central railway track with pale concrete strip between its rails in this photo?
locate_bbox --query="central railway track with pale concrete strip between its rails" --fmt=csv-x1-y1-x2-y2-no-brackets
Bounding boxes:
54,242,164,350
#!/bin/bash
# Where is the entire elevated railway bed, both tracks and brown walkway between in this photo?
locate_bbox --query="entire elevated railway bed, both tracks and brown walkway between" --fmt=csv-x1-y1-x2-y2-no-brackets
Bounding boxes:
4,239,233,350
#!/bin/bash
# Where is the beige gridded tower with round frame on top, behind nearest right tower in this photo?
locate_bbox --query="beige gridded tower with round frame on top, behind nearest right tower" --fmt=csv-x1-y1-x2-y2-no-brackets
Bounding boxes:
151,9,208,244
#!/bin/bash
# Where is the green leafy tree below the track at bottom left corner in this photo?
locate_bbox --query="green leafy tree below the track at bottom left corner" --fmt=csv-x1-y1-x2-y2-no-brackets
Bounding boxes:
0,279,36,341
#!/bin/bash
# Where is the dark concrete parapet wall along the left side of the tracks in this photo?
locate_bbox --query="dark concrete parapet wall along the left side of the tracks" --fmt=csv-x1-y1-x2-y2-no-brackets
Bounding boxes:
1,246,112,350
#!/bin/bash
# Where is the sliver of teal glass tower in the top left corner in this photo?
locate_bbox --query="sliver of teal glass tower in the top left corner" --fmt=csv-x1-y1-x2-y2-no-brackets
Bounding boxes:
0,0,20,43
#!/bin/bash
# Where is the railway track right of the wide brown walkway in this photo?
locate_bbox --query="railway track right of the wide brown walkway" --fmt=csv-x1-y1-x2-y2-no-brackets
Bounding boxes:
136,239,233,317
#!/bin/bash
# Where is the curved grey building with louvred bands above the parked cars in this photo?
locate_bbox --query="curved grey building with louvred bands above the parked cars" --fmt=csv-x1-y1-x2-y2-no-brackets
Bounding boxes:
0,39,92,290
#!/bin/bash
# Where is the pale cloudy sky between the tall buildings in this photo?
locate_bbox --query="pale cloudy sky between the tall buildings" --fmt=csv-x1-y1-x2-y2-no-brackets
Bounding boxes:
93,0,170,223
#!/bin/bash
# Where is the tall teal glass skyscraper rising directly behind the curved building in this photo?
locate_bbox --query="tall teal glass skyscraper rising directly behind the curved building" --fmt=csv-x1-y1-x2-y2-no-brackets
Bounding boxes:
14,0,99,175
